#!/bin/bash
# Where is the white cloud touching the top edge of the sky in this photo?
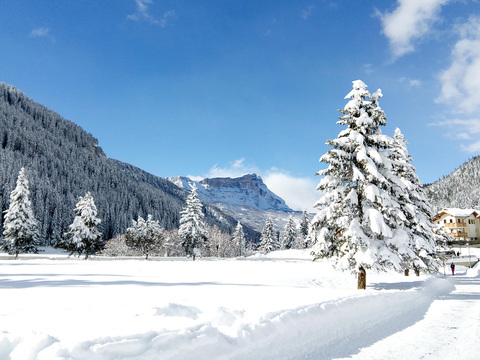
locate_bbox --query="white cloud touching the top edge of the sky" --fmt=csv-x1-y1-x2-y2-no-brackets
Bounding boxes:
378,0,450,59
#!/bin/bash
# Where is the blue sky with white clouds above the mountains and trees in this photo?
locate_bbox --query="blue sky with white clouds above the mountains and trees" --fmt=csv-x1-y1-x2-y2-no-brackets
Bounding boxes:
0,0,480,209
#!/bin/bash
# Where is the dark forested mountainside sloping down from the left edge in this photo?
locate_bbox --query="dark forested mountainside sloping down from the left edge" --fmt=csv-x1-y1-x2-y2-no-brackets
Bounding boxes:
0,83,253,244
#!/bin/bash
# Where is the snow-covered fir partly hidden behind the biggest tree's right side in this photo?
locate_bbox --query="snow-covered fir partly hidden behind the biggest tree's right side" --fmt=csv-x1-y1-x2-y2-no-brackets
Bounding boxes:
389,128,439,274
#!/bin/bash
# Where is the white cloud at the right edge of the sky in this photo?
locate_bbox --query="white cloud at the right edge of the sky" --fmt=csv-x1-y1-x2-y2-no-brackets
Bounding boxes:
437,17,480,114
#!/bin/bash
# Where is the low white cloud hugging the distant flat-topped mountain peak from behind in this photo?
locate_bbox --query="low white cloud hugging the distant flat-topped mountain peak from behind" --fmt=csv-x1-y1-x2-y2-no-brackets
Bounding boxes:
200,158,320,212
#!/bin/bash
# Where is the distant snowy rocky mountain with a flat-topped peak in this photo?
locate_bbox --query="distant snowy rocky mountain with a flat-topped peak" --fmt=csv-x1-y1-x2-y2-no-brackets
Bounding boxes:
168,174,301,231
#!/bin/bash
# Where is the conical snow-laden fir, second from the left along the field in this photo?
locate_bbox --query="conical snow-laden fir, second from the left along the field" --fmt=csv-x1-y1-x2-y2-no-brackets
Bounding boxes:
59,192,102,260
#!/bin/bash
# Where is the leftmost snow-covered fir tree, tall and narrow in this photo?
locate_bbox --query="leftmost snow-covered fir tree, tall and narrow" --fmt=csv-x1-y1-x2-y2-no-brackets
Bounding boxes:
0,168,39,259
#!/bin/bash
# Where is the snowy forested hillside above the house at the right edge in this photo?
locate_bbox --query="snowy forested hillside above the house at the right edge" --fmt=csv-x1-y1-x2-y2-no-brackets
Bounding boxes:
425,156,480,211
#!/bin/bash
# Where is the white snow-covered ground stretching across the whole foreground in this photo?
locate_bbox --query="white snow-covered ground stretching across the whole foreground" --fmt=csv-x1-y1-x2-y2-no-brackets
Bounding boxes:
0,250,480,360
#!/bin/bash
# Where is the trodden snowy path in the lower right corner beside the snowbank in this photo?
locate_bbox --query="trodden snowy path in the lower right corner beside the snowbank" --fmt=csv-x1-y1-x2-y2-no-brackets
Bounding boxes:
334,265,480,360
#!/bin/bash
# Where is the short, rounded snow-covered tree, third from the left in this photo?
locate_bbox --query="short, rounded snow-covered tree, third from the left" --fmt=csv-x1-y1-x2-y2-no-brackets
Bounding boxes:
125,215,164,259
